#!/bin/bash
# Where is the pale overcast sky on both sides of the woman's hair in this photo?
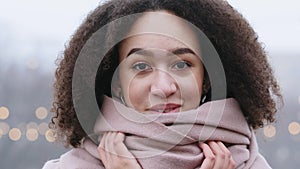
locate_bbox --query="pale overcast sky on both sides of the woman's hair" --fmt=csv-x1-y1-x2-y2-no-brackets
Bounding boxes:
0,0,300,71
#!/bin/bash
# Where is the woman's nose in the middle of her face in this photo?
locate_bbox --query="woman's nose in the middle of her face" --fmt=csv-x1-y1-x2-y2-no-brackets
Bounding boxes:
150,70,177,98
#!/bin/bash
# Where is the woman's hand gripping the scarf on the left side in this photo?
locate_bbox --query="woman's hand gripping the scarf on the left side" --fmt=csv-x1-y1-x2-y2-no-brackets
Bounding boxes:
98,132,141,169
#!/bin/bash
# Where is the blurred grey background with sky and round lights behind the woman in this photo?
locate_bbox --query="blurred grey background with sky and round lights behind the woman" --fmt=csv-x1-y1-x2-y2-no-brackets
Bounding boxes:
0,0,300,169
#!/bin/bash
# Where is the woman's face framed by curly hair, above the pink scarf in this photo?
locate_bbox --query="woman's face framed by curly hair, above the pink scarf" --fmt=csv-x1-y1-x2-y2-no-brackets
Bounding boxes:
119,11,203,113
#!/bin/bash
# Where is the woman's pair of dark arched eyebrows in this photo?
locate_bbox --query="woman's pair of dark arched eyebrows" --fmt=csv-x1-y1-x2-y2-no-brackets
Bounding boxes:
126,48,196,57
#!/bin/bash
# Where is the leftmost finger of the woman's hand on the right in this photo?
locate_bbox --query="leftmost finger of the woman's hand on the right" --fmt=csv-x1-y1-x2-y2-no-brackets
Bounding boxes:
199,143,215,169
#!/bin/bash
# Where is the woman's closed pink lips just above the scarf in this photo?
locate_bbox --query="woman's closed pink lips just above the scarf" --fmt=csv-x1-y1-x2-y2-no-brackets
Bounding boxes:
147,103,181,113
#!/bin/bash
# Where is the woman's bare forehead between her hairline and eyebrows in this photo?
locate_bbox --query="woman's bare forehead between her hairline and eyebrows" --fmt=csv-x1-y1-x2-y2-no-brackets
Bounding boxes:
120,11,199,56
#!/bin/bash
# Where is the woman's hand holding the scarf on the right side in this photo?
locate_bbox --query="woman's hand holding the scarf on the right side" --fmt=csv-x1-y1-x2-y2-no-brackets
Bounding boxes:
199,141,235,169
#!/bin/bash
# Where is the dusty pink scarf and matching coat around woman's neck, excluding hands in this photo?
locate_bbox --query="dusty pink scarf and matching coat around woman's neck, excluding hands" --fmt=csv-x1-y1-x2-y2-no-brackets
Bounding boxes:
42,97,271,169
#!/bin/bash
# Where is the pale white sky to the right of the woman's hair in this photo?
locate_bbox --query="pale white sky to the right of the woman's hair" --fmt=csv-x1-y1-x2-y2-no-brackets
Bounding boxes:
228,0,300,53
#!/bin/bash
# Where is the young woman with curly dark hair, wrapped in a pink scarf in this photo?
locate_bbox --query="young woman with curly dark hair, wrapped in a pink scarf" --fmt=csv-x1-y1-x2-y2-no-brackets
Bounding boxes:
44,0,281,168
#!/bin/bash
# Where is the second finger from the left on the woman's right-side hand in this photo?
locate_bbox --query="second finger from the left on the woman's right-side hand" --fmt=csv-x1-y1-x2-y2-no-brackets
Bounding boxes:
208,141,229,169
